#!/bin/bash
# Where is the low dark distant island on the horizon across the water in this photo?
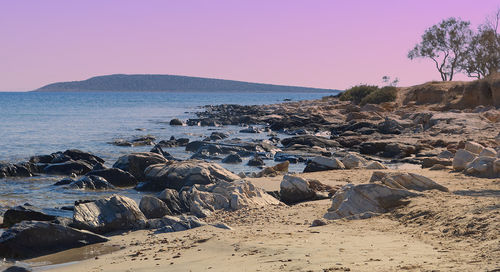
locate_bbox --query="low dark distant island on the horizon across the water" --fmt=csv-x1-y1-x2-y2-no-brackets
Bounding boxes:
34,74,339,93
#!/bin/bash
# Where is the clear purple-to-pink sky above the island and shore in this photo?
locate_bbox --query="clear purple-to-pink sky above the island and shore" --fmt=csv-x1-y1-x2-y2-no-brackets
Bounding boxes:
0,0,500,91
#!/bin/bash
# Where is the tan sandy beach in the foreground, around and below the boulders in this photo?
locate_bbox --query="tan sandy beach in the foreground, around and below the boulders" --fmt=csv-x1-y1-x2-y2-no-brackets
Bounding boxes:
29,169,500,271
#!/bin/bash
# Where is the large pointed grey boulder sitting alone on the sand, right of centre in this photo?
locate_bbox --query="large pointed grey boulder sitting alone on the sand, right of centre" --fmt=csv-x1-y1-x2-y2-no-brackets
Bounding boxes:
324,184,418,220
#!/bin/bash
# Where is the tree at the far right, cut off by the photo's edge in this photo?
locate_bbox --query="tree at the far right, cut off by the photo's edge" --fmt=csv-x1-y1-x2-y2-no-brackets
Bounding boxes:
461,8,500,79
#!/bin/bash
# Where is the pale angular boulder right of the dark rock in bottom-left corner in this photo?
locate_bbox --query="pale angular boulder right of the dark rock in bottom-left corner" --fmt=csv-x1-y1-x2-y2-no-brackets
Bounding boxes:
73,195,146,233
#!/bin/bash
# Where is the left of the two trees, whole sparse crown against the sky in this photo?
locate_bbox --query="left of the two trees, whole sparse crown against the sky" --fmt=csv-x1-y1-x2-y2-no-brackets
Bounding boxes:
408,17,472,81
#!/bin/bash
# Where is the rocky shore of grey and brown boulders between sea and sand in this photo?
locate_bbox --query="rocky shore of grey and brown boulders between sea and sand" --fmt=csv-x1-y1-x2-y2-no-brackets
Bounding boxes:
0,77,500,272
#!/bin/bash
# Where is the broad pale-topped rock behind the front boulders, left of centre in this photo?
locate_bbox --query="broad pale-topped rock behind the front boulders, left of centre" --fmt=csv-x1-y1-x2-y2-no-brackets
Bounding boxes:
137,160,239,191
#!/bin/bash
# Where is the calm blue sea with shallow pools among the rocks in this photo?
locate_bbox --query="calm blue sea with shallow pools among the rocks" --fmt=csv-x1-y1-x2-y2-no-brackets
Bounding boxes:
0,92,335,217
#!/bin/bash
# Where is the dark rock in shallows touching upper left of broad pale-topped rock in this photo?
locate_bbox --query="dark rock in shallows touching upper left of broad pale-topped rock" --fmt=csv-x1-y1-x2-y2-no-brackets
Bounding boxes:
113,152,167,181
